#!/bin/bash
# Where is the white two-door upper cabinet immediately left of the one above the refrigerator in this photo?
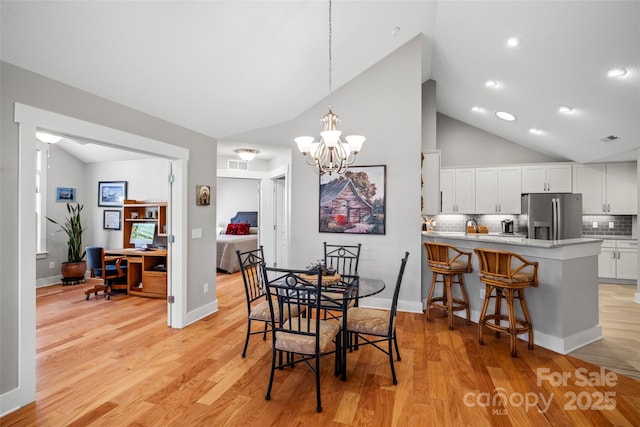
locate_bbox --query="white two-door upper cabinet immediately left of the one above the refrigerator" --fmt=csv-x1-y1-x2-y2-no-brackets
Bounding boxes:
476,166,522,214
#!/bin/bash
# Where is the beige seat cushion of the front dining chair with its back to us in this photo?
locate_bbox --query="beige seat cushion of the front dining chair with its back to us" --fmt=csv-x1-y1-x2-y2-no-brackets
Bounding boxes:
276,317,340,354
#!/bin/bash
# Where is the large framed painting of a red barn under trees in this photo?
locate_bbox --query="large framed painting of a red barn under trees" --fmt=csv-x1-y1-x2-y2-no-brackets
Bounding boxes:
318,165,387,234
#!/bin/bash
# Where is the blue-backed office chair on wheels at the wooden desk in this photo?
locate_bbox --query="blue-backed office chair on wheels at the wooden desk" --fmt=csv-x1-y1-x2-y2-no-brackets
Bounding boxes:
84,246,127,300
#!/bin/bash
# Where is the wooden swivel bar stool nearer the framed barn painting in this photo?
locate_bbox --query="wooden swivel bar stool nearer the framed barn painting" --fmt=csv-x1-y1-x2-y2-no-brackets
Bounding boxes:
424,242,471,330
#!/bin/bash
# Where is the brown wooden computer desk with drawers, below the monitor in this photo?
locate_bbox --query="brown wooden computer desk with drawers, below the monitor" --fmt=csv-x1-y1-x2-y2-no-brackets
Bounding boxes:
105,248,167,298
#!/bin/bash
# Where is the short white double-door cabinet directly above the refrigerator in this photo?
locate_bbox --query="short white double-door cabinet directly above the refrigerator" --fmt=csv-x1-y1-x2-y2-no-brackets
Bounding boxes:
522,163,573,193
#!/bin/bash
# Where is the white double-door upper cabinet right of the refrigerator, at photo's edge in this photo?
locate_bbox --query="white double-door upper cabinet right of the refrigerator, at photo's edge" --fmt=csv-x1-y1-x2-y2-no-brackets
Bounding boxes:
573,162,638,215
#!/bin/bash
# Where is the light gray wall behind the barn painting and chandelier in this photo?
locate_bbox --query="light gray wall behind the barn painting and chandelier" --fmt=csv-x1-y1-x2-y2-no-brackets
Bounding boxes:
283,37,422,310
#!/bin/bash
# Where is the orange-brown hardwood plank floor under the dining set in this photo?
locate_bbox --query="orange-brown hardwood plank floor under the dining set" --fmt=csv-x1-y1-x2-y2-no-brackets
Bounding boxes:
0,274,640,427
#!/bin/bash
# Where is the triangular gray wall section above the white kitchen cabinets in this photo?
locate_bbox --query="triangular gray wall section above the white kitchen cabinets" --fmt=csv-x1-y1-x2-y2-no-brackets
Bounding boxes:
437,113,565,167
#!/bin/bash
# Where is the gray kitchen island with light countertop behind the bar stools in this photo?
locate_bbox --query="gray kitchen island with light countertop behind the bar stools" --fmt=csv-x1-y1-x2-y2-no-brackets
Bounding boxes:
422,232,602,354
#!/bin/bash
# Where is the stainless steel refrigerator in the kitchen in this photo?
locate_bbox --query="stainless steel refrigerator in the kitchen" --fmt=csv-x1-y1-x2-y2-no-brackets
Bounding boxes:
518,193,582,240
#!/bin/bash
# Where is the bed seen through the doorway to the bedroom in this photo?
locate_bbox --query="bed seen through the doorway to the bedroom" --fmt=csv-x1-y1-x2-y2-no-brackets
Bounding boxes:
216,211,258,273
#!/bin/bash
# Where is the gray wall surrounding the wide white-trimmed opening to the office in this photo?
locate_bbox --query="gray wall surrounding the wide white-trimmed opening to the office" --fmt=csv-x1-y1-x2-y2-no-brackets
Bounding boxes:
0,62,216,400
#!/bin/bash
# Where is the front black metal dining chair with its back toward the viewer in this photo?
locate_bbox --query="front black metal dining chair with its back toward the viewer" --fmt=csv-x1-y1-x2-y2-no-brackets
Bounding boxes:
262,264,341,412
